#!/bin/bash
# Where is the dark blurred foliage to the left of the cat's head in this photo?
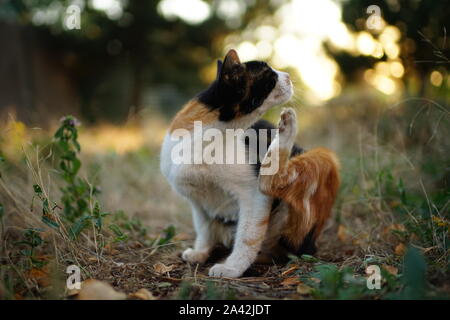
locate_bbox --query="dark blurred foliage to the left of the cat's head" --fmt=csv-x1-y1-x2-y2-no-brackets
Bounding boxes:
0,0,271,121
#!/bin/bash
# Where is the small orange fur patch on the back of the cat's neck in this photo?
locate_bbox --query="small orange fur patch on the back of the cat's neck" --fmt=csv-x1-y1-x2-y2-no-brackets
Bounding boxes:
169,99,219,132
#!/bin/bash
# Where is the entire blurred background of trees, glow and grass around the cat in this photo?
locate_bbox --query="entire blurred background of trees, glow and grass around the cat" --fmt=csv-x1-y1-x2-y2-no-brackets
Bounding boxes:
0,0,450,298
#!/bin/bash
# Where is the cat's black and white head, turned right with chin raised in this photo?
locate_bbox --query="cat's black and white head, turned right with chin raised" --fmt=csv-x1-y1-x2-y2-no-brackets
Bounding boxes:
198,50,293,122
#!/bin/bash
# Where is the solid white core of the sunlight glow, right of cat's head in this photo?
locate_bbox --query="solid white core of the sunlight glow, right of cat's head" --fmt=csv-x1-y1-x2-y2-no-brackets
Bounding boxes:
268,0,344,100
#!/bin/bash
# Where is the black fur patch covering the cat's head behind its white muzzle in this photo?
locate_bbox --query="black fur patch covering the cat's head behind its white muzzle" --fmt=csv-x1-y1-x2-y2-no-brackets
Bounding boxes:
197,60,278,122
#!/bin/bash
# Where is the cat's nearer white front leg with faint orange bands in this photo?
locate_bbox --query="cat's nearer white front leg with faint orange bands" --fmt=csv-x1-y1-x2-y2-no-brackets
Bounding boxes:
209,190,272,278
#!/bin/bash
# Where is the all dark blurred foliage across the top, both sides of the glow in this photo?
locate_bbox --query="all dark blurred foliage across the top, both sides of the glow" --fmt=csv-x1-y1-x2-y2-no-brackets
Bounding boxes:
0,0,450,122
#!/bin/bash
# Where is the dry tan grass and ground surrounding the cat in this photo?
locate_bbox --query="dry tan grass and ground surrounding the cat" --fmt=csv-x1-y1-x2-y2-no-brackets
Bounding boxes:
0,93,449,299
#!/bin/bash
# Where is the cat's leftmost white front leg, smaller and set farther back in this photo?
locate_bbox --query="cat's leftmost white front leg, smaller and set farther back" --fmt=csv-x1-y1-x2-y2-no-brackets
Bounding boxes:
181,203,215,263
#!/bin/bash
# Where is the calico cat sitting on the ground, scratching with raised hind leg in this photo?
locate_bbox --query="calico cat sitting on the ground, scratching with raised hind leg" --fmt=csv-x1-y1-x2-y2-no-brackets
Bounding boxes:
161,50,339,277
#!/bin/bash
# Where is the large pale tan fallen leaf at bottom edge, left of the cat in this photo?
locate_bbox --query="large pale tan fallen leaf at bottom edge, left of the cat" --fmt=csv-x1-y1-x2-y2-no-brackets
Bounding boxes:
77,279,127,300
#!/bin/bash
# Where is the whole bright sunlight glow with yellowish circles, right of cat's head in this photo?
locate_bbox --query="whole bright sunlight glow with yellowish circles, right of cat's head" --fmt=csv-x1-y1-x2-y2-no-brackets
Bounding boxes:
225,0,406,103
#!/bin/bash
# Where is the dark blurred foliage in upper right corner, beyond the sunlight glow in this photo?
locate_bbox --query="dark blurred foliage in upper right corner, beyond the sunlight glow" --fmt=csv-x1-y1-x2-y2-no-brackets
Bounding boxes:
340,0,450,96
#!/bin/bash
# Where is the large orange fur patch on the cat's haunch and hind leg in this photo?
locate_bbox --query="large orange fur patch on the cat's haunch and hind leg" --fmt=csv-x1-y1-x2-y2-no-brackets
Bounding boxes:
260,148,340,248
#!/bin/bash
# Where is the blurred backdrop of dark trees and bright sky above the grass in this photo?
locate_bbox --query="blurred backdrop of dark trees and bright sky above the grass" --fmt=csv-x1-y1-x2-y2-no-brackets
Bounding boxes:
0,0,450,125
